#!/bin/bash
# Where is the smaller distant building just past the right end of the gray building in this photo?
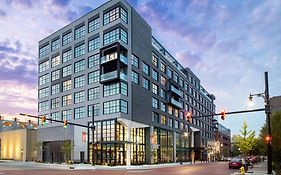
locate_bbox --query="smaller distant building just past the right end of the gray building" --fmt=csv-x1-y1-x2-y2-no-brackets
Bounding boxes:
215,123,231,159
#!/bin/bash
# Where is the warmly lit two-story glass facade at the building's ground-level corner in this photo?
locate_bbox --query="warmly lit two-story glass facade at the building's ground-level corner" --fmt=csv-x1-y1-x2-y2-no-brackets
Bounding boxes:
88,119,146,165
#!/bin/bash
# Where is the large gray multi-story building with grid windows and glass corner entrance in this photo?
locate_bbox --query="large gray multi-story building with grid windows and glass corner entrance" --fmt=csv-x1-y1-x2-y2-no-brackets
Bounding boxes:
38,0,215,165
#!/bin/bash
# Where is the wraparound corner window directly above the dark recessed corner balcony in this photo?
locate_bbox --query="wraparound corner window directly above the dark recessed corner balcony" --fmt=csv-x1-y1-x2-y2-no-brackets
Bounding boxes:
103,28,128,45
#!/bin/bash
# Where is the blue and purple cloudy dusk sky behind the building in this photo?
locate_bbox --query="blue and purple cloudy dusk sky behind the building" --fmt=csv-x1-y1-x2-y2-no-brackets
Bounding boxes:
0,0,281,134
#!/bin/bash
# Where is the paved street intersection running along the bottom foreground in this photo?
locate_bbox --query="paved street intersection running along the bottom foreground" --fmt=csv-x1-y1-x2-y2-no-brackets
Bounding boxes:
0,162,238,175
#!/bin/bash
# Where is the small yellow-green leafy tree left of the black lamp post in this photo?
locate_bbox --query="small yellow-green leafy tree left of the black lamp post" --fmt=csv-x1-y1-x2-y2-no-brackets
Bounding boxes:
233,121,257,155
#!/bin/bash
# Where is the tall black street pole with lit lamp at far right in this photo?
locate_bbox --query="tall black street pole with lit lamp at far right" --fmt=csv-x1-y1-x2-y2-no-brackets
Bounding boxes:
249,72,272,174
